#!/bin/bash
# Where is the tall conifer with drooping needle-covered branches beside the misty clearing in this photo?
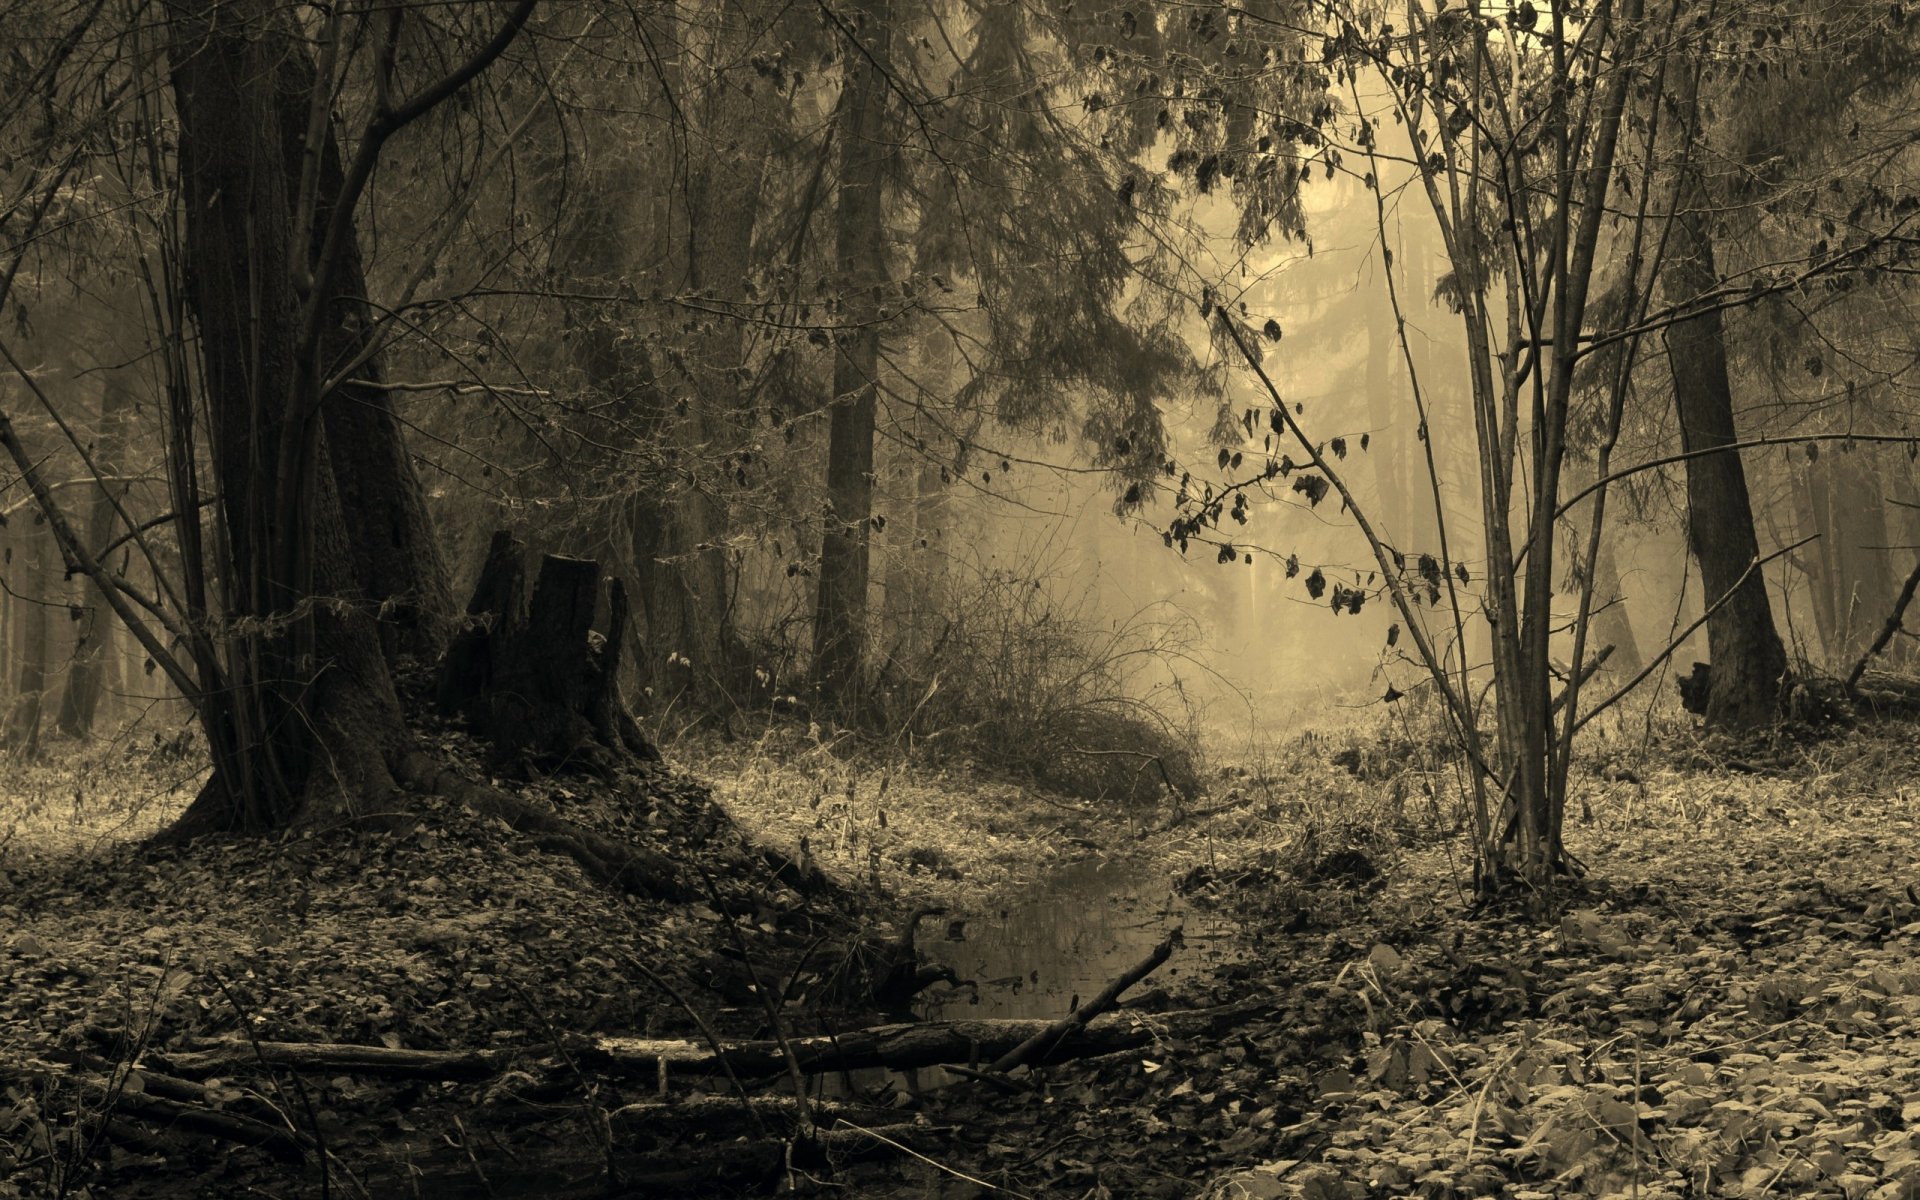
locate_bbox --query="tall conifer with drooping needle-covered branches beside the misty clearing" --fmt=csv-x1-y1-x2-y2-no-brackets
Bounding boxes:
814,2,1311,699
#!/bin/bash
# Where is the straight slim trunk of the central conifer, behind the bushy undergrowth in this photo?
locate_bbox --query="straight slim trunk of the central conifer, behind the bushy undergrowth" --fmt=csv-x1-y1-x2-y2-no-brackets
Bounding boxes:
814,0,893,712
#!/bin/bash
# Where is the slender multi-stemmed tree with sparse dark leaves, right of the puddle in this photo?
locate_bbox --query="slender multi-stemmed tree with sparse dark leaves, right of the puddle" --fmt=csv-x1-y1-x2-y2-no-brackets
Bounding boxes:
1171,0,1665,895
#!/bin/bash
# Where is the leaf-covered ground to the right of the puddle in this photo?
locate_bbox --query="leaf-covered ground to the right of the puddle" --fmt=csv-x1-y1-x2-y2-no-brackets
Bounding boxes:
821,730,1920,1200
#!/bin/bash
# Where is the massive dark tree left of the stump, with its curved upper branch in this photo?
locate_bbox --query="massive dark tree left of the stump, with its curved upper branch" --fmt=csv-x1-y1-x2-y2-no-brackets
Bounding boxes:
152,0,532,829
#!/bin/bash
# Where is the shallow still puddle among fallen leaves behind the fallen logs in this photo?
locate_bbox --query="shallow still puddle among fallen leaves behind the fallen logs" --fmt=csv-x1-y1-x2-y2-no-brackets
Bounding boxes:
914,858,1238,1021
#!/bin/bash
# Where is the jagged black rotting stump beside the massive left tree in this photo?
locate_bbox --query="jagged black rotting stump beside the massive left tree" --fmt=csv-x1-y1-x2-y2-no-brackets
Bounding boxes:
438,530,659,774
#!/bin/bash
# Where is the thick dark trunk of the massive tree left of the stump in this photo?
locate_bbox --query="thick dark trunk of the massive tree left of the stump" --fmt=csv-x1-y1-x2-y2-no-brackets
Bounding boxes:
169,0,416,835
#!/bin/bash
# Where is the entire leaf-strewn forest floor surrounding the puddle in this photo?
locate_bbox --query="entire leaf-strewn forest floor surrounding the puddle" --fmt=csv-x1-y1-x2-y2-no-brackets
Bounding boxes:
0,702,1920,1200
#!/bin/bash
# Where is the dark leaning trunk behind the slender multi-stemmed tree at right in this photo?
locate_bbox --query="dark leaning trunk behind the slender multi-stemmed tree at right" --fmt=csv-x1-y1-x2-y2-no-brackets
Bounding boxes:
1665,166,1788,730
